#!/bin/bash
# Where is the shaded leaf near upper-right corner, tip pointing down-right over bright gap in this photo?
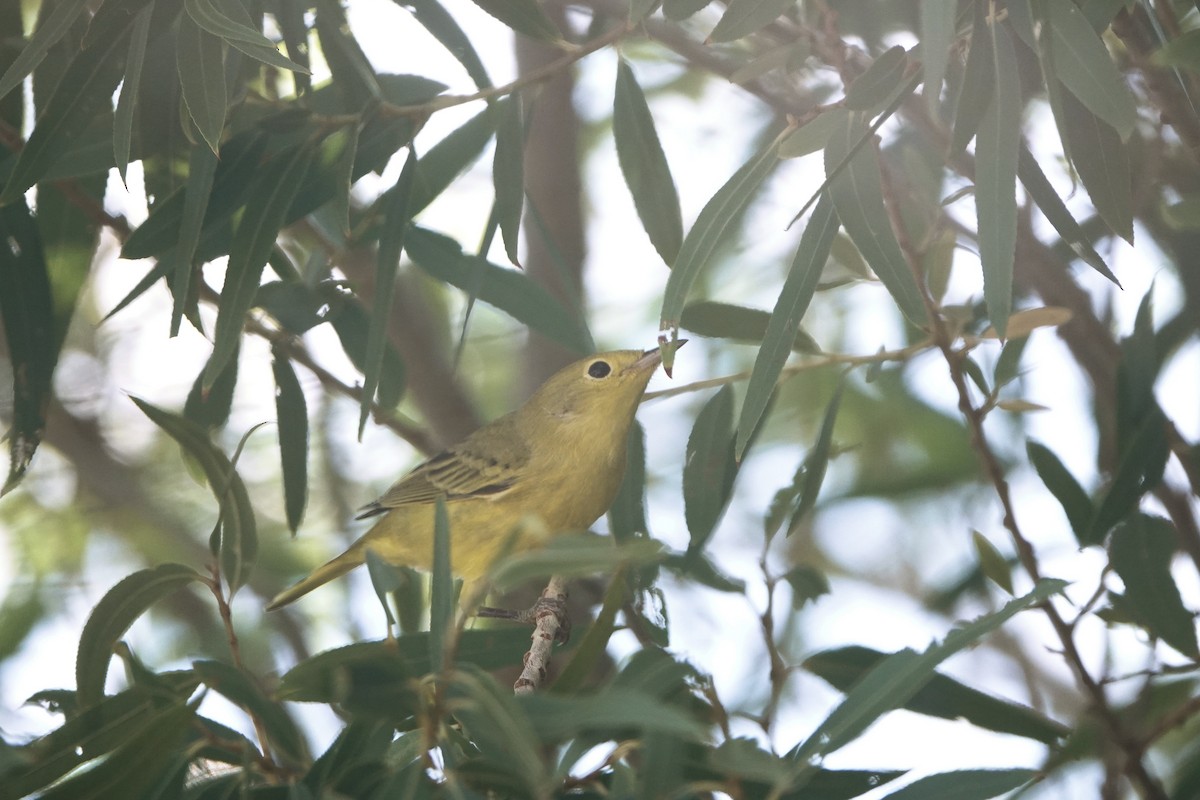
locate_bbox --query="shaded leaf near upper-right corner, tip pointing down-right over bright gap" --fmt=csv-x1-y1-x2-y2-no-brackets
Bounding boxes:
1055,83,1133,245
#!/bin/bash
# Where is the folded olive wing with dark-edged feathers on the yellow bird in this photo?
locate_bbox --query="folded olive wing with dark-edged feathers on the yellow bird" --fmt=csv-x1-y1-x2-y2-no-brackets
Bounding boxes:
359,429,529,519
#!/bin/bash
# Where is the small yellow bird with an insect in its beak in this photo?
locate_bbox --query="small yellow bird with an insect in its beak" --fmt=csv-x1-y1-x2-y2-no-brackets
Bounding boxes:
266,342,682,610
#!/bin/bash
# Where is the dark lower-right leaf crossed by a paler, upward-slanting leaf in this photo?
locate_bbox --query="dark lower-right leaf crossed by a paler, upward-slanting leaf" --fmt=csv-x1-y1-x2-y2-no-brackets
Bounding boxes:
803,645,1070,745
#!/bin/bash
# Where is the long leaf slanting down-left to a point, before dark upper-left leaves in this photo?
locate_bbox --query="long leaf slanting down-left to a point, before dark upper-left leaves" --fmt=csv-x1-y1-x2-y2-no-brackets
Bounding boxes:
204,146,313,386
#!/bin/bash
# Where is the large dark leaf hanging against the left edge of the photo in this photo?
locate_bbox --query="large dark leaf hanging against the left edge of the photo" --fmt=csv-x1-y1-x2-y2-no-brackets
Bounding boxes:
0,198,59,495
